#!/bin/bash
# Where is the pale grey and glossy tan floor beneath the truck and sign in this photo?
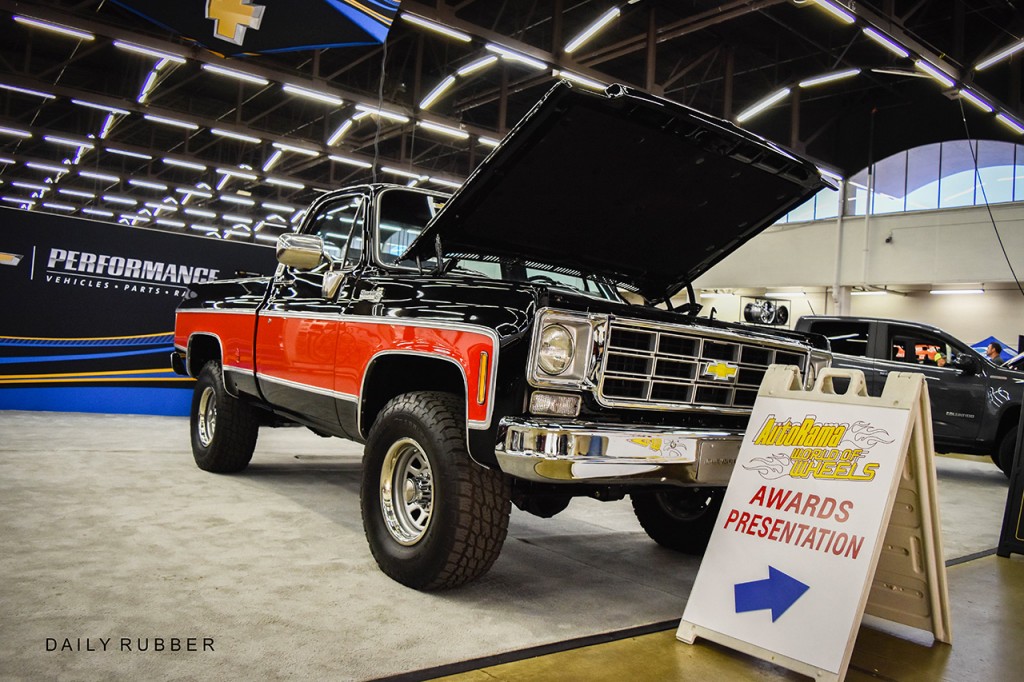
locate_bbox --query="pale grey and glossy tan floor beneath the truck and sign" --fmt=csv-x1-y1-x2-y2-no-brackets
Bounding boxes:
0,412,1024,680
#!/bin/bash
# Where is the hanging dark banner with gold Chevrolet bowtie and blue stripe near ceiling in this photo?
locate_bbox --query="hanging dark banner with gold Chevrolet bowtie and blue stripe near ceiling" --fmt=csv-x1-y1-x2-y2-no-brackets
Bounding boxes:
113,0,399,54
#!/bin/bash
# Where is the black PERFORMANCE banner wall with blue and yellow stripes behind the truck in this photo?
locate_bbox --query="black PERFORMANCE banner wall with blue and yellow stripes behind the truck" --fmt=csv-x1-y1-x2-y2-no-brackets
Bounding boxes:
0,209,276,415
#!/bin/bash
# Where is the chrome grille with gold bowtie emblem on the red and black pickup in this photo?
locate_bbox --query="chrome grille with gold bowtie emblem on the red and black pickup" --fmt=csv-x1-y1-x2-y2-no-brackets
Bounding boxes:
597,321,807,411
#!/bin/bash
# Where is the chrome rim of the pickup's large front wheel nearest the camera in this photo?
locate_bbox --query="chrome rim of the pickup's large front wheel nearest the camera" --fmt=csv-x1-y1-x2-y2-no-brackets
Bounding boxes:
380,438,434,546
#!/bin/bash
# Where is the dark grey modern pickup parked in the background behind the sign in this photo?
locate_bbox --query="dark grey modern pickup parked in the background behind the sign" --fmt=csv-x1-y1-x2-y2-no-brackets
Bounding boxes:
797,315,1024,476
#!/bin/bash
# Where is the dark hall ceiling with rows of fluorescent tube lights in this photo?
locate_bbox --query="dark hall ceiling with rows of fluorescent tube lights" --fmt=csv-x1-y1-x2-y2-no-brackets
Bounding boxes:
0,0,1024,241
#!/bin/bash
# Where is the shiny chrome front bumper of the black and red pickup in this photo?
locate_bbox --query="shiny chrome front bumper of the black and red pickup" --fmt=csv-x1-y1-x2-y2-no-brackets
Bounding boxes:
495,418,742,485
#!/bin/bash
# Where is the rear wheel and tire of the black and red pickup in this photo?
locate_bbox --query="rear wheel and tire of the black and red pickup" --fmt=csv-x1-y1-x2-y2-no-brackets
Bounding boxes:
189,360,259,473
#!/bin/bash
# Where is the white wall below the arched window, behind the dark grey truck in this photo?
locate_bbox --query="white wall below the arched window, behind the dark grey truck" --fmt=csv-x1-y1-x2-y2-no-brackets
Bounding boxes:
694,204,1024,346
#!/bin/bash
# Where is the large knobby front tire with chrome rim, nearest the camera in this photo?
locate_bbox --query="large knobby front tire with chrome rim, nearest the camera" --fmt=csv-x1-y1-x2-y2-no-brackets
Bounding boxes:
360,392,511,590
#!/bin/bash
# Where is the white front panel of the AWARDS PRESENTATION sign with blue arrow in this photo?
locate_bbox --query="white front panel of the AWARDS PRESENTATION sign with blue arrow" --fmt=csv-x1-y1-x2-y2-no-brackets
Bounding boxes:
679,368,914,677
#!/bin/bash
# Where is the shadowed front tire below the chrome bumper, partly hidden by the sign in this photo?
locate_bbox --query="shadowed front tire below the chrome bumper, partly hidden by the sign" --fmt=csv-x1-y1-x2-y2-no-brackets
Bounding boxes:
630,487,725,554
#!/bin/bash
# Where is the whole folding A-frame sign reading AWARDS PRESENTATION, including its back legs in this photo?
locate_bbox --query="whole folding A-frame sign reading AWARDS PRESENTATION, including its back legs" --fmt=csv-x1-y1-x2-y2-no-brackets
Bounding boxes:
677,366,952,680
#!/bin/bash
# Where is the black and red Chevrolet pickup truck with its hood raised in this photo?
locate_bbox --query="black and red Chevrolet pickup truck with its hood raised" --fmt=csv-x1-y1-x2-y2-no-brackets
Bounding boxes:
173,84,829,589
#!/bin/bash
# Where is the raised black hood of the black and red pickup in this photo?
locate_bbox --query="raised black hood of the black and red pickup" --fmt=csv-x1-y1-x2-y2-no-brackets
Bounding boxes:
406,83,825,299
